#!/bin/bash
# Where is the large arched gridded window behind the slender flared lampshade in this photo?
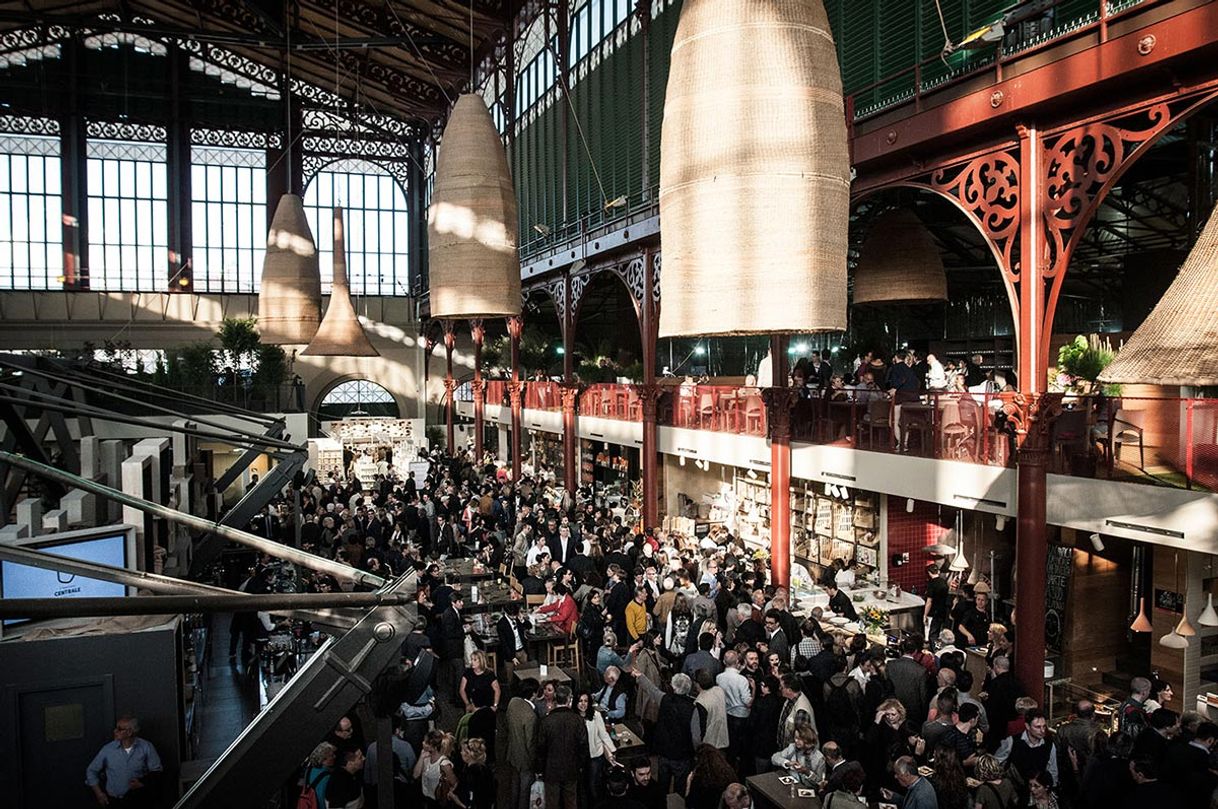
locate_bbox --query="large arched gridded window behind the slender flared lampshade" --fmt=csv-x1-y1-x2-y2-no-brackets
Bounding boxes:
305,160,410,295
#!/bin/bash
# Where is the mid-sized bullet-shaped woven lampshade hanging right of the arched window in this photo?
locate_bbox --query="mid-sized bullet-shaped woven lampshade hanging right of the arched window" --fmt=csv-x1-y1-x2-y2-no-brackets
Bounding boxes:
428,94,520,318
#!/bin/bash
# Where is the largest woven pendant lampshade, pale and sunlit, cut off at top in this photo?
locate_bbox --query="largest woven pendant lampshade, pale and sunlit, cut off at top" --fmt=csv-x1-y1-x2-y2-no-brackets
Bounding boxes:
659,0,850,337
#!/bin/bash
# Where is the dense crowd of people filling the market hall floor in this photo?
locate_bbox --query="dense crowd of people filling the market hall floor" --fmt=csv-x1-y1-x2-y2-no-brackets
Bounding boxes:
224,456,1218,809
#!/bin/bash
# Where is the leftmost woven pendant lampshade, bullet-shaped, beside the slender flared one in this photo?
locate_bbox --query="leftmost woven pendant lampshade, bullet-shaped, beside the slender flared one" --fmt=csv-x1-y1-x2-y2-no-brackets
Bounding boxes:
258,194,322,346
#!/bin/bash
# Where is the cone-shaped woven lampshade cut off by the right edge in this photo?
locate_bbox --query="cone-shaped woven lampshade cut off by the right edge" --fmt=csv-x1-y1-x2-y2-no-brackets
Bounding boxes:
1100,208,1218,386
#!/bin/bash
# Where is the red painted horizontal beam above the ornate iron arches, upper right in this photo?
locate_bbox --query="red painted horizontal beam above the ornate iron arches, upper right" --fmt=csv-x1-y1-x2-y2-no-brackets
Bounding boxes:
851,0,1218,173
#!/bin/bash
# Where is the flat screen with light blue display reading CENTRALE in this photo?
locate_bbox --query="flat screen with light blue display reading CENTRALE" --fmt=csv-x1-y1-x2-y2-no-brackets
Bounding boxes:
0,525,135,626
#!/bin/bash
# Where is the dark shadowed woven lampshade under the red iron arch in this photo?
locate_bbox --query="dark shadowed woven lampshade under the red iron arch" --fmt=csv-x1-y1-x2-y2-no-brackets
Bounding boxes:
854,208,948,303
